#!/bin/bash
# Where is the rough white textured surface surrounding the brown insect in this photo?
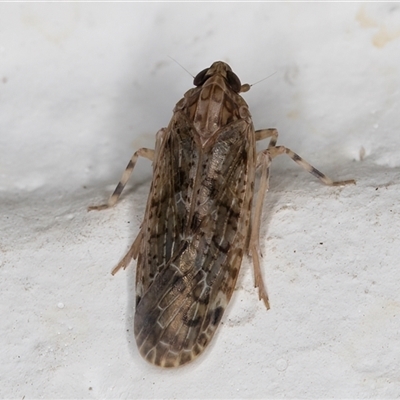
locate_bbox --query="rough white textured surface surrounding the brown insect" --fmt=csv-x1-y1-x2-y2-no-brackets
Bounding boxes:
0,3,400,399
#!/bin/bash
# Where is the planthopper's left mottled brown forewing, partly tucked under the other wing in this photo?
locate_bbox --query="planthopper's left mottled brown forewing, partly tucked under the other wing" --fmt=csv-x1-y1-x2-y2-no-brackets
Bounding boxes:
136,112,196,304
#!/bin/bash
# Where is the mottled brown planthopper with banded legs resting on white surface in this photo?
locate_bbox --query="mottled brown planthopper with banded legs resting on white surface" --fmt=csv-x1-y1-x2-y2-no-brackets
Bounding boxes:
90,62,354,367
